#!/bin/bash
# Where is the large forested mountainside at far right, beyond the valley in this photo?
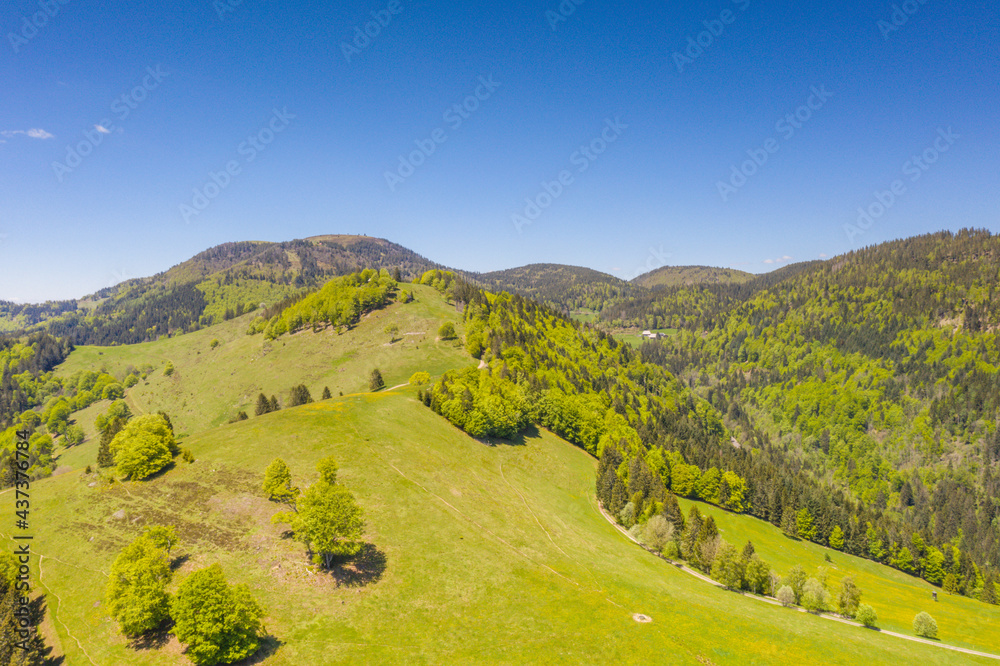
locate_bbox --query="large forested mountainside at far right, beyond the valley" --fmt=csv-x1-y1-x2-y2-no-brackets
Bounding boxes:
655,230,1000,594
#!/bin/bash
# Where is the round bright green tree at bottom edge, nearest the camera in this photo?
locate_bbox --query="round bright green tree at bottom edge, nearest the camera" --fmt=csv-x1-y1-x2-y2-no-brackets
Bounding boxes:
170,564,264,666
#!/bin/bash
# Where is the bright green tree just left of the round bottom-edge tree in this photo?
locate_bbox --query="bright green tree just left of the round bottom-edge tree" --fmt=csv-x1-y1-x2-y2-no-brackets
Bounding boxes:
105,526,177,636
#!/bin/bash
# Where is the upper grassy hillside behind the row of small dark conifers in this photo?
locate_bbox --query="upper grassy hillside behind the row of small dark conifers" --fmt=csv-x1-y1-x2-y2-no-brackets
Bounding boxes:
56,284,474,438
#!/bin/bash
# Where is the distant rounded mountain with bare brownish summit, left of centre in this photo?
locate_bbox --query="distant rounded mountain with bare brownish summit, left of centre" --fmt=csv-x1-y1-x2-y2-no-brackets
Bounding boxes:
0,235,437,345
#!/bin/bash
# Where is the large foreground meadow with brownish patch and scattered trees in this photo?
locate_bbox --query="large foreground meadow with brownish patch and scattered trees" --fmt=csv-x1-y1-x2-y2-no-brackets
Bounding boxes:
6,389,987,665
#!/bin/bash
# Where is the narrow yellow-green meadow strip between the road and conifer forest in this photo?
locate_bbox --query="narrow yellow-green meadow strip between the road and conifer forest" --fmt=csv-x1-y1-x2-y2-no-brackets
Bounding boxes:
680,492,1000,658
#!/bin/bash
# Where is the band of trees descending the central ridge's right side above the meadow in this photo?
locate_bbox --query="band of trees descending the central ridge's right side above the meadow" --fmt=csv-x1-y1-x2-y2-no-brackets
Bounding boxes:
423,270,996,596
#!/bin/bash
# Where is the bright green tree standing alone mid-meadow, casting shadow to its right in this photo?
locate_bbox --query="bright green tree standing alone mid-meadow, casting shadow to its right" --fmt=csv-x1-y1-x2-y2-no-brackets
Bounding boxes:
272,479,364,568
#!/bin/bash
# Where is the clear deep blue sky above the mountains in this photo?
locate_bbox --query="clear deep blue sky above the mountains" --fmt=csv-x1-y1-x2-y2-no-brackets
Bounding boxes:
0,0,1000,301
